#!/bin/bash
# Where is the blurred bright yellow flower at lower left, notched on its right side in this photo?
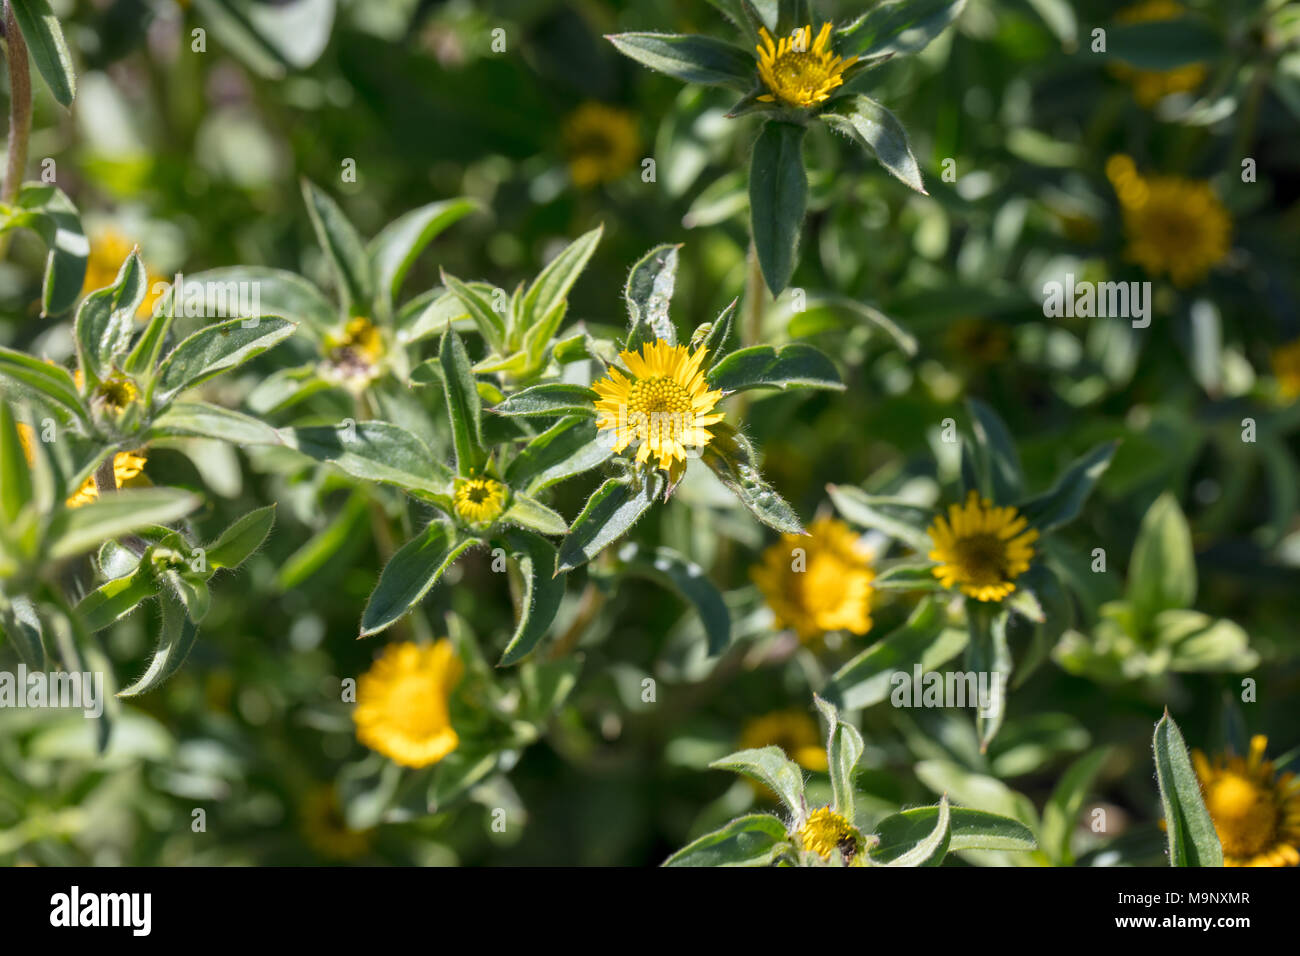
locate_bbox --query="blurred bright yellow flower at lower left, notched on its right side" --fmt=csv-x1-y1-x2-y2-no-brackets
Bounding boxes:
352,639,463,767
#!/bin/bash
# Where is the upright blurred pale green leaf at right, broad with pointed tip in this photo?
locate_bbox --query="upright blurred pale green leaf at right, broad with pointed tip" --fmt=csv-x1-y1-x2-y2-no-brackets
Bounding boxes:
1127,492,1196,633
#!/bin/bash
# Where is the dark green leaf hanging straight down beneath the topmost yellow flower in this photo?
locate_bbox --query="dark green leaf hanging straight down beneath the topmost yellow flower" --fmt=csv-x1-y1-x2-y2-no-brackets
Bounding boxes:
749,122,807,295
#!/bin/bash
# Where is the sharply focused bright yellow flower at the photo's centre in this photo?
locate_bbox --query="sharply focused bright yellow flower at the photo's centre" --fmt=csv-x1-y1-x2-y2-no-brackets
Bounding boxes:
592,339,723,475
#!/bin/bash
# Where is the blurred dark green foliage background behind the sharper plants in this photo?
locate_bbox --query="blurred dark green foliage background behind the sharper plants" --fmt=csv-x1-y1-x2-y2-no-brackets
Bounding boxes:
0,0,1300,865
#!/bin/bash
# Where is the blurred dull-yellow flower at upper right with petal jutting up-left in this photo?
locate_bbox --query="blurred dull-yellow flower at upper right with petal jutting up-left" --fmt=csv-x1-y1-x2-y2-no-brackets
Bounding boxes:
1106,156,1232,286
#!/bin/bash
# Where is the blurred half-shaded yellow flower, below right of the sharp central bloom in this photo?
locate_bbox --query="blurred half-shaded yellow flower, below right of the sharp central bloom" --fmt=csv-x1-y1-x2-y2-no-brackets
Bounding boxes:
751,518,876,641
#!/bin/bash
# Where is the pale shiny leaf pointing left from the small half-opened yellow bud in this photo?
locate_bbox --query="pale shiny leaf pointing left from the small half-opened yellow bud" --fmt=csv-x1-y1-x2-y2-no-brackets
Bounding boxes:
281,421,452,497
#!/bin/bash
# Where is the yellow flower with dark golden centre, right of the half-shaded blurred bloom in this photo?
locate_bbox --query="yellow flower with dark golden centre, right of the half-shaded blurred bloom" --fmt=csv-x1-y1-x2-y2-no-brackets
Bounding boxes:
927,492,1039,601
